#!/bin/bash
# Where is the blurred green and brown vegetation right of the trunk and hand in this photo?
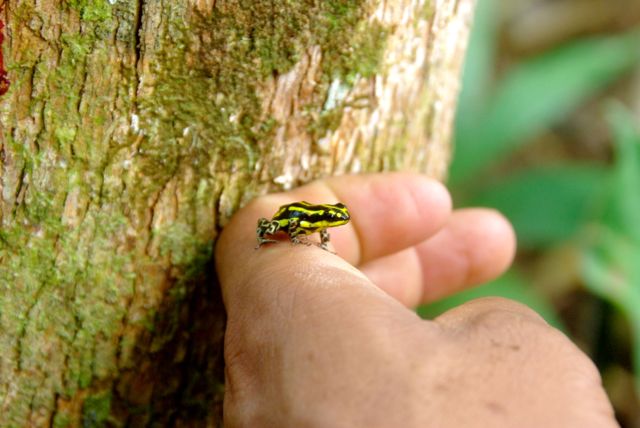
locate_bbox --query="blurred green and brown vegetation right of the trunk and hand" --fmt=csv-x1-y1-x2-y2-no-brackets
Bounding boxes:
419,0,640,427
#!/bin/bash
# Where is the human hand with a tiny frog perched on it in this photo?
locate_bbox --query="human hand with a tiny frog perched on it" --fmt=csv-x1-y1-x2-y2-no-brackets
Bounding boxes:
216,173,617,428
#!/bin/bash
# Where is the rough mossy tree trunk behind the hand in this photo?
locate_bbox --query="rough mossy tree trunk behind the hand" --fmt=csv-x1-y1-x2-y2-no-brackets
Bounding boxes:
0,0,472,427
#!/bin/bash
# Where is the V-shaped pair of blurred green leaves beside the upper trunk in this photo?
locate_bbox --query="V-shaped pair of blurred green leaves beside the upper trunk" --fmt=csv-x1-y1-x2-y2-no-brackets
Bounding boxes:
450,0,640,185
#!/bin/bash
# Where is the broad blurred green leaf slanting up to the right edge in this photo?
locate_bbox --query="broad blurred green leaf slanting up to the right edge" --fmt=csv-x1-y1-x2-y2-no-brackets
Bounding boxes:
451,30,640,183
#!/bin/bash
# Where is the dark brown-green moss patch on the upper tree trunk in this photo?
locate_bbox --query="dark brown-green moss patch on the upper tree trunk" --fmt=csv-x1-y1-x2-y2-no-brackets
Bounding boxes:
138,0,387,183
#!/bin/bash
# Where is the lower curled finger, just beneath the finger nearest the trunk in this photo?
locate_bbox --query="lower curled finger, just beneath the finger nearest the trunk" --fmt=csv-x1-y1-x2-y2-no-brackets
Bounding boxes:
360,208,515,307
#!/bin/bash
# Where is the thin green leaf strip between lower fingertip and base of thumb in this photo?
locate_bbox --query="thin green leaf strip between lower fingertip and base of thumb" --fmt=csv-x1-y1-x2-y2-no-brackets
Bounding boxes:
418,269,564,330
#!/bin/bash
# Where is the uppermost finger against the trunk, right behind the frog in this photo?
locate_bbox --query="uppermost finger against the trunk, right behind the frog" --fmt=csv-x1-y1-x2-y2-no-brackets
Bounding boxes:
218,173,451,280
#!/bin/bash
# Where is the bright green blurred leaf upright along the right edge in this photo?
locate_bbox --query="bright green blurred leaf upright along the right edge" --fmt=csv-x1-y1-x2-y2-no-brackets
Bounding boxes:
582,104,640,393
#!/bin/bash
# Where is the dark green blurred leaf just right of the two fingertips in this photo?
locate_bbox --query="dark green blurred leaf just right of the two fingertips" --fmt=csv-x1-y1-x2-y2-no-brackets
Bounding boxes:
470,165,607,248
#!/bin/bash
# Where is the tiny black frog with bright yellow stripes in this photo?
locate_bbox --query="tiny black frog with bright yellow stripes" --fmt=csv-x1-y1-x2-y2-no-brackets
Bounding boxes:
256,201,350,250
